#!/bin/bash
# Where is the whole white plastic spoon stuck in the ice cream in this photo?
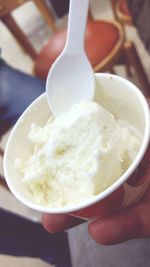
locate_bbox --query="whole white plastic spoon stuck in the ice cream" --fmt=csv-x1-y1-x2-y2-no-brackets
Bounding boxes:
46,0,95,115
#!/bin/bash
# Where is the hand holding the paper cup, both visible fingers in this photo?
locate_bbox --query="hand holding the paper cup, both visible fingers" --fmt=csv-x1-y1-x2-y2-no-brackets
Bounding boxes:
43,187,150,245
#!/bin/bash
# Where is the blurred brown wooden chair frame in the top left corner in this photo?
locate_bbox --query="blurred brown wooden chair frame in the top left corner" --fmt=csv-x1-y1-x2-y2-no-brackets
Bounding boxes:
0,0,57,59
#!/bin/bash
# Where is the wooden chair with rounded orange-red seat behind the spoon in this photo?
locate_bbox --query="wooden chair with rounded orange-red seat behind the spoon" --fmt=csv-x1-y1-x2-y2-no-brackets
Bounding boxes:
34,9,150,96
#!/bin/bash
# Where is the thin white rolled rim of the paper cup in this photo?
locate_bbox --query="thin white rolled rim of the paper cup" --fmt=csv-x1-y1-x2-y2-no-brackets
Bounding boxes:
3,73,150,214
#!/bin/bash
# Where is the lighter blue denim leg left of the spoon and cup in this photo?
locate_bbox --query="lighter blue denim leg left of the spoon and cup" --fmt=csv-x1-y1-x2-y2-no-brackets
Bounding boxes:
0,60,45,137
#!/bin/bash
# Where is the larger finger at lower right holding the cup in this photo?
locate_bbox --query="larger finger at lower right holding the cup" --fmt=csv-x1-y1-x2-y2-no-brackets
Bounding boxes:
89,201,150,245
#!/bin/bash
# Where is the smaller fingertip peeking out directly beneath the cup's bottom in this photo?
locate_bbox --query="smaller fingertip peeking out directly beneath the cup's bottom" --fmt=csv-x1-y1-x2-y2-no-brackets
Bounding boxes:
42,214,84,233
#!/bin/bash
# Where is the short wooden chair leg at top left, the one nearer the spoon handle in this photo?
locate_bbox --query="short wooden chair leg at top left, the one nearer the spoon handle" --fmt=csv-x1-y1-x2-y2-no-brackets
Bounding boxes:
33,0,58,33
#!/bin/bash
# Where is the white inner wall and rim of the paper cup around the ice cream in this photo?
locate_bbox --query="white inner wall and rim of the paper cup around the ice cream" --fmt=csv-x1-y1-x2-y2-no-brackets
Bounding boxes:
4,73,150,213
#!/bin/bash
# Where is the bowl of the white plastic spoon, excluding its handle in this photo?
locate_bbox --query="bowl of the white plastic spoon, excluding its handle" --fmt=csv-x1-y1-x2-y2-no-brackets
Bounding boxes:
46,53,95,115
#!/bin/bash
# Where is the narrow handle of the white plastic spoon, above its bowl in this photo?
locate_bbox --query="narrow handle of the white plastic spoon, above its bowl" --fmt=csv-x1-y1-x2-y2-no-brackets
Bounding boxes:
65,0,89,54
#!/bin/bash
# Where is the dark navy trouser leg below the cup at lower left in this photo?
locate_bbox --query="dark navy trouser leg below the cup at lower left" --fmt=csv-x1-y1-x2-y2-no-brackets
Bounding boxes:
0,209,71,267
